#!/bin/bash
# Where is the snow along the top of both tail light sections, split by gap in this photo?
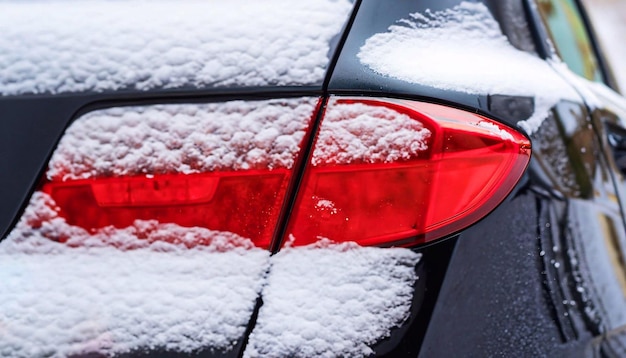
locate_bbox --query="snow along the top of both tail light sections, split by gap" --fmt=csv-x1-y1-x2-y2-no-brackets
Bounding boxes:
47,98,431,180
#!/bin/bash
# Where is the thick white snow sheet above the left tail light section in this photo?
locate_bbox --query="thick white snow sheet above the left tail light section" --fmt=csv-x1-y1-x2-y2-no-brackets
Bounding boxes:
0,0,352,95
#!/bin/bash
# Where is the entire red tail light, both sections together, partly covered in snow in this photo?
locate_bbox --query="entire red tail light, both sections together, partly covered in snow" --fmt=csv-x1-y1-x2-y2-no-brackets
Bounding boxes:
11,97,530,248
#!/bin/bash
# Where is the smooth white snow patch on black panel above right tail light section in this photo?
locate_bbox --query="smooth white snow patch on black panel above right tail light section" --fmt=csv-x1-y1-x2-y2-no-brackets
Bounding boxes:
358,1,577,134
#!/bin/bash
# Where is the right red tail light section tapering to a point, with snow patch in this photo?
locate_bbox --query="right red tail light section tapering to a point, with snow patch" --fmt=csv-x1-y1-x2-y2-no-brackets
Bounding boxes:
287,98,530,249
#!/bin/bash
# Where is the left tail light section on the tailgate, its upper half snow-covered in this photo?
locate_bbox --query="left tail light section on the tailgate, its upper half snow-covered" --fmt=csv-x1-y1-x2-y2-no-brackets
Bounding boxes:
31,98,318,247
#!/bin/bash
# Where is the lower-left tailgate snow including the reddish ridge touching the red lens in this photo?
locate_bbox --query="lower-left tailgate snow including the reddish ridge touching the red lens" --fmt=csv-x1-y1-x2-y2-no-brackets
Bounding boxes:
0,197,269,357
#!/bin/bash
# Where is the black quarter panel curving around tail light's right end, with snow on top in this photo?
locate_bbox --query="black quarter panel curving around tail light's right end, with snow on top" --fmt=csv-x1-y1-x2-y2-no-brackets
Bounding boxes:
328,0,624,356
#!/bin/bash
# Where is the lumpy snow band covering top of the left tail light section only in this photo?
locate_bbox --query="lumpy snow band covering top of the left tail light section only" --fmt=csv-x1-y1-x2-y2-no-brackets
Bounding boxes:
47,98,317,180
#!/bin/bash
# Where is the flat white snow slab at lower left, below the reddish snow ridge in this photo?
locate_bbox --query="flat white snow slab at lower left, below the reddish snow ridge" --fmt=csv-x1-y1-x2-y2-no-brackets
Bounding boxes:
0,249,267,357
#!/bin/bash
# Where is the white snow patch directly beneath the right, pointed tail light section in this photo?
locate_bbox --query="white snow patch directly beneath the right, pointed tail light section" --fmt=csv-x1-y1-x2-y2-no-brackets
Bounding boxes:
244,243,420,357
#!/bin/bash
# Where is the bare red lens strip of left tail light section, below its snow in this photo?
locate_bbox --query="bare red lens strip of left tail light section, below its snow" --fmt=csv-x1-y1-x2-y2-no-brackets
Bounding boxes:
42,169,291,247
